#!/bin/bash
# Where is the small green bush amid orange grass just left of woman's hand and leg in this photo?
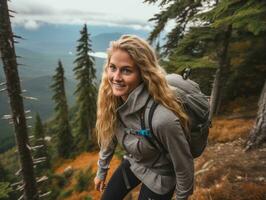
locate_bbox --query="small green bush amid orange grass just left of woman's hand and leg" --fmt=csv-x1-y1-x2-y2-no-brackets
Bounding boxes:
75,167,95,192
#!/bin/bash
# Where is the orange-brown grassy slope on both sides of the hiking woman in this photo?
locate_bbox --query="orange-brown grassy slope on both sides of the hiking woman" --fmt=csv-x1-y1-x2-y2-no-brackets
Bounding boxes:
50,97,266,200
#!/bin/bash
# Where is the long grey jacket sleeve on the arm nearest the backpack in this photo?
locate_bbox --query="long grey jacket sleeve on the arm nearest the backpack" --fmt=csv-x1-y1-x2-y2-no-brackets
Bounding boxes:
155,113,194,200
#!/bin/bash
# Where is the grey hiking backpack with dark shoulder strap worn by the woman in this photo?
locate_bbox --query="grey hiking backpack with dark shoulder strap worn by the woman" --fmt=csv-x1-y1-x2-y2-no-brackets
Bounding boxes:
139,74,211,158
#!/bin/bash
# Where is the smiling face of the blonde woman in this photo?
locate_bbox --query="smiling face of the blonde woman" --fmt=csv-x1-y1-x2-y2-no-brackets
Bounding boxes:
107,49,141,101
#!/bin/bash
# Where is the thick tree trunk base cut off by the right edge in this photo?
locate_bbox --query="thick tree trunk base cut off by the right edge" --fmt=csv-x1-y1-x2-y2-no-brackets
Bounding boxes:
245,81,266,151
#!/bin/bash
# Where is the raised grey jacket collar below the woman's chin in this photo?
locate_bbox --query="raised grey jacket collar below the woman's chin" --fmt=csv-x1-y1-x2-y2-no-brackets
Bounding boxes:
117,83,149,116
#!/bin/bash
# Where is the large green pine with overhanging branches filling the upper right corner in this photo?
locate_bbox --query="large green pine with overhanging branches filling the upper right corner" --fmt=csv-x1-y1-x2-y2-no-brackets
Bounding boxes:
148,0,266,115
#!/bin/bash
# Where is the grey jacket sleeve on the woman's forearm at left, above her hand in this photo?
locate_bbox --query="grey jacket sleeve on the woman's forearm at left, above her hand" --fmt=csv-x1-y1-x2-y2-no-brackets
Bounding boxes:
96,138,117,180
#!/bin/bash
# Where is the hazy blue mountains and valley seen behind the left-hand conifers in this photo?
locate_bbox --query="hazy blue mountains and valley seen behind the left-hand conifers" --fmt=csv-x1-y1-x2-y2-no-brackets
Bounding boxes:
0,25,148,152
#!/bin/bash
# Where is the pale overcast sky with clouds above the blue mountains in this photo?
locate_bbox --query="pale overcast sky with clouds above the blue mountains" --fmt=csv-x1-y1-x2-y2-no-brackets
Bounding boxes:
9,0,159,30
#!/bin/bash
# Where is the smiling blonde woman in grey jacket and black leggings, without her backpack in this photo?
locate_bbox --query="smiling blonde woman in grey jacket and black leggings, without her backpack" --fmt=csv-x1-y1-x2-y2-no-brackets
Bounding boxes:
94,35,194,200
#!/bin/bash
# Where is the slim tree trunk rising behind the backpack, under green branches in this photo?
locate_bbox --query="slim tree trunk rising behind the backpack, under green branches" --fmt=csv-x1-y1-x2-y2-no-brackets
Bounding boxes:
210,25,232,119
